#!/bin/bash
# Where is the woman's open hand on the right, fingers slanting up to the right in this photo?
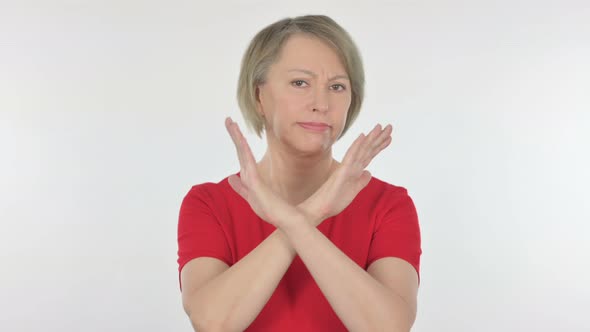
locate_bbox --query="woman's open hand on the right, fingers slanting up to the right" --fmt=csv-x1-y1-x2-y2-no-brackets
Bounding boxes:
297,125,393,226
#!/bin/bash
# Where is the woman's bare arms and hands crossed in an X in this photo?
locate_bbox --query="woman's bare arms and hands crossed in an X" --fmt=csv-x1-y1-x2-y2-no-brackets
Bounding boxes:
181,118,418,331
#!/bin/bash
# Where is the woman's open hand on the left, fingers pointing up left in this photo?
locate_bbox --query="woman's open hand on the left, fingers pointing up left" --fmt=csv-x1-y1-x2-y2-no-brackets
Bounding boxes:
225,117,299,228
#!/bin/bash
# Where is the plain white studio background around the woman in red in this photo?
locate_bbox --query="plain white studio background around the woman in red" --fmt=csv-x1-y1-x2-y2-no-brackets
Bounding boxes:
0,0,590,332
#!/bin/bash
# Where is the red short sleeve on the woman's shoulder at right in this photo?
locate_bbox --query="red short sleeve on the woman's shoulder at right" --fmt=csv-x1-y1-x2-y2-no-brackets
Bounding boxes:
367,187,422,280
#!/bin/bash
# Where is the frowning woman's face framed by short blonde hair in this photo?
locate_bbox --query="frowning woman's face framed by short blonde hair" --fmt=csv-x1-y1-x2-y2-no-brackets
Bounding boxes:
257,35,351,154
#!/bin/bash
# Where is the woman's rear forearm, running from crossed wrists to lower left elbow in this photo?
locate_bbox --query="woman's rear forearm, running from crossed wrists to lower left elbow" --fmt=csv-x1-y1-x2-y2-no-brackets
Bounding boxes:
190,229,296,331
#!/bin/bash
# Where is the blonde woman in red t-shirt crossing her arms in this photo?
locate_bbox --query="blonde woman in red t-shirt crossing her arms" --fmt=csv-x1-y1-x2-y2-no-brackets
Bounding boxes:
178,15,422,331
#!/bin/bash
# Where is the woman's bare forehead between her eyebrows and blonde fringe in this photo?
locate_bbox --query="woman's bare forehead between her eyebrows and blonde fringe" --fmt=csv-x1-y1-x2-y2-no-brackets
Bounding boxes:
276,35,346,74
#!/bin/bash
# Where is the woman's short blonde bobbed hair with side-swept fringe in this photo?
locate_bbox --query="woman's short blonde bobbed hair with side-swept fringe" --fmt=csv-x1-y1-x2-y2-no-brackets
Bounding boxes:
237,15,365,137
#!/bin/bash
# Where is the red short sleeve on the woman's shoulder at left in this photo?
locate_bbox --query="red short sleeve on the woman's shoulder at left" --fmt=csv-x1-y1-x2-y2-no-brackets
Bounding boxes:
178,185,232,289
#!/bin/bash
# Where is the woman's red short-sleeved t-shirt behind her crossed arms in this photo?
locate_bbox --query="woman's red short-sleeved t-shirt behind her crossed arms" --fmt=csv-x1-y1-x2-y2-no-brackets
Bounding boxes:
178,172,422,331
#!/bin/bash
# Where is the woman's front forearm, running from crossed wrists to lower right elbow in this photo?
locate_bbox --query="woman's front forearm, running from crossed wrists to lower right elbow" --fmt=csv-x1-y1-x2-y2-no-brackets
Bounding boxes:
282,216,412,331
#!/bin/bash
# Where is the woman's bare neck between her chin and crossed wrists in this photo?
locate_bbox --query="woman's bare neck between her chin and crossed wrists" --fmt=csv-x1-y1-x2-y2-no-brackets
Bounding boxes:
258,148,339,205
